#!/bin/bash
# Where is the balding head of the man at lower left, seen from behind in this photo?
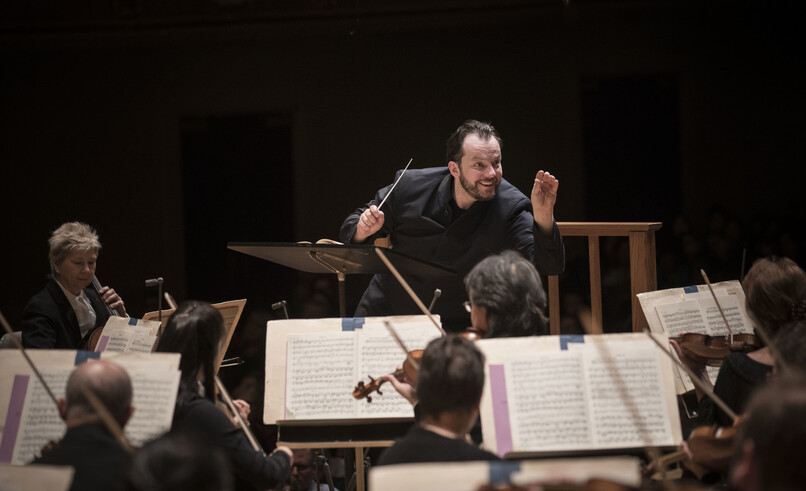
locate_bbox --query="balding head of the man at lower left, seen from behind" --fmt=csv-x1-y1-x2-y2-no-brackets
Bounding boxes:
59,360,133,428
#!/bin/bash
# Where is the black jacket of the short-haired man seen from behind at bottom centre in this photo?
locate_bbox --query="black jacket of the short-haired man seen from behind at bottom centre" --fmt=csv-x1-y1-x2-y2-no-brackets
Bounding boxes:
377,425,499,465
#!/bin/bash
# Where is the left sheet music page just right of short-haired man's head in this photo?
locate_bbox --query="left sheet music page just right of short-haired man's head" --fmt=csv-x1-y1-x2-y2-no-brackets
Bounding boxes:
504,352,591,454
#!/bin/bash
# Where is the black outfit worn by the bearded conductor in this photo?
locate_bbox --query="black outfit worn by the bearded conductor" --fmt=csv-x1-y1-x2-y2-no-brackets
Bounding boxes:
340,166,565,331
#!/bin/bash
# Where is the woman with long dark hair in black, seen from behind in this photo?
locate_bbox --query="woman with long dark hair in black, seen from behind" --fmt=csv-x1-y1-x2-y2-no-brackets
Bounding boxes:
157,301,291,489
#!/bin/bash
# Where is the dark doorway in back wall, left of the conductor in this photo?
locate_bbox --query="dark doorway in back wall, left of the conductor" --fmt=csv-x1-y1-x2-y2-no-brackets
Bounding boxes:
182,114,294,310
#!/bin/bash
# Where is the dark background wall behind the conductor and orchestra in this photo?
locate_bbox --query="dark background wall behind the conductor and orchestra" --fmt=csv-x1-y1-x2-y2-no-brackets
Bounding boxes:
0,0,806,334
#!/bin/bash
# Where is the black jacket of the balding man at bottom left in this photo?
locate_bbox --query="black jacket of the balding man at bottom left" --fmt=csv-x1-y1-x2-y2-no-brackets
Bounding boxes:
33,422,130,491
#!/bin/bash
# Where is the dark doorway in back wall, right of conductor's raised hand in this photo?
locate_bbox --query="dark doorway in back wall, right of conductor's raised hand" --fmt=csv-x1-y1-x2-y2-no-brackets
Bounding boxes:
582,75,681,222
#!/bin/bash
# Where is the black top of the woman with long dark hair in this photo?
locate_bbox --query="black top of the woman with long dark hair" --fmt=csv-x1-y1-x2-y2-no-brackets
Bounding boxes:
172,390,291,489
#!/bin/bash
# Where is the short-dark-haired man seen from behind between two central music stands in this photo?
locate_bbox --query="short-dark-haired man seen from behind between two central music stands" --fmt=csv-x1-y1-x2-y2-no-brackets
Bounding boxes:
378,334,498,465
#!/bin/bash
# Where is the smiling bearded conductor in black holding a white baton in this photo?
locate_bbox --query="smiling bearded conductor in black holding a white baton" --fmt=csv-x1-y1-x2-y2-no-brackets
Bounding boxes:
340,120,565,331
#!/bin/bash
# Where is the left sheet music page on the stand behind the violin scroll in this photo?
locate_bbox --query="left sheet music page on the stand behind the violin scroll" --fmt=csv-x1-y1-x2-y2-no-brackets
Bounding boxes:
285,332,357,419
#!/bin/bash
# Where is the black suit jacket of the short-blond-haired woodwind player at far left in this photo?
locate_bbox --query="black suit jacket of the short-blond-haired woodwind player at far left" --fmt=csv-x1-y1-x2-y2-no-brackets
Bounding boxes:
22,279,109,349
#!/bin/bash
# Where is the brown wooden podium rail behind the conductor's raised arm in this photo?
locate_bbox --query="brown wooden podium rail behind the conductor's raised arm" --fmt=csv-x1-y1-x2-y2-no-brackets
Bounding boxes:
548,222,662,334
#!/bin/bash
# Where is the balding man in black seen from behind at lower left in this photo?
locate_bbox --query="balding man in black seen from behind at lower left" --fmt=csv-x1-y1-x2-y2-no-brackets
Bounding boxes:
33,360,134,491
